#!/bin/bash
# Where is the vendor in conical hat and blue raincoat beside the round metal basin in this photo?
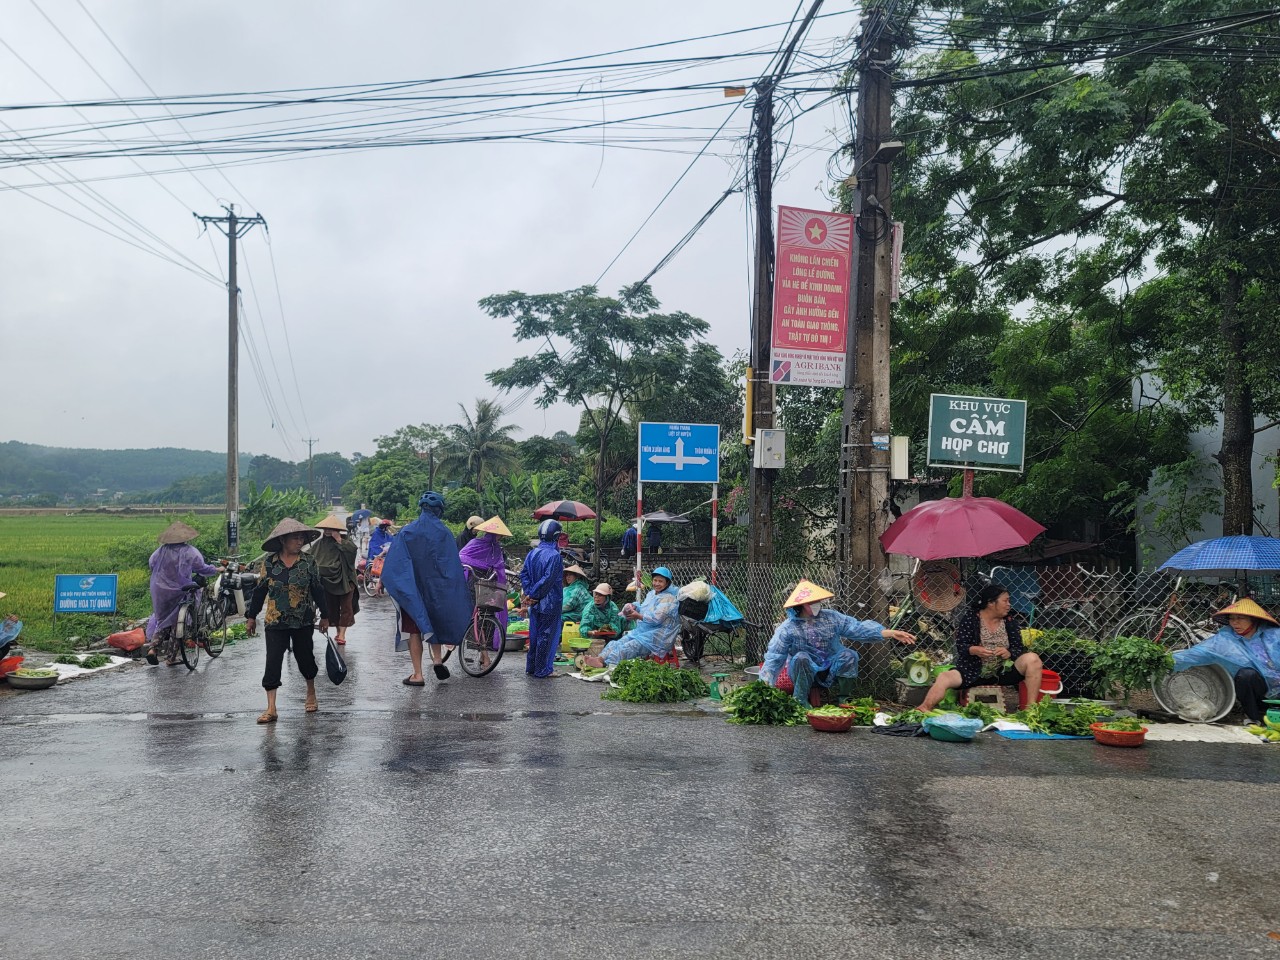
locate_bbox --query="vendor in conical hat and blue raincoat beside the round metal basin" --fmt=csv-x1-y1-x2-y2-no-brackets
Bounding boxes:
1174,596,1280,724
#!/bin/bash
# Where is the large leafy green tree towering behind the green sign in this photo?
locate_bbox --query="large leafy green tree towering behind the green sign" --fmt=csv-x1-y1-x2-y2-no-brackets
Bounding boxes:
893,0,1280,534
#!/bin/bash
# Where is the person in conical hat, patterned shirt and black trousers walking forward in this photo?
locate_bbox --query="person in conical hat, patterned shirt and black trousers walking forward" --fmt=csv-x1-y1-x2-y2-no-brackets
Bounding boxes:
244,517,329,723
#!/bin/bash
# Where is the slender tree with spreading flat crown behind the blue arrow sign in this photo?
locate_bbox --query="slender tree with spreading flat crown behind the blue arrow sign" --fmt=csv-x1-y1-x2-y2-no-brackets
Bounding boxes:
480,284,709,563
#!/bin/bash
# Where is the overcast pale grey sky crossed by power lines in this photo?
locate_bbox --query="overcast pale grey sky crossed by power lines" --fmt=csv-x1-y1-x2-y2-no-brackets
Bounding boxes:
0,0,856,460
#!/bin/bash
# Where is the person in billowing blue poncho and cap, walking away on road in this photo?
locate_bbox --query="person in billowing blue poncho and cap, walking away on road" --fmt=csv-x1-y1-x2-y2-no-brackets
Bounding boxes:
383,490,471,686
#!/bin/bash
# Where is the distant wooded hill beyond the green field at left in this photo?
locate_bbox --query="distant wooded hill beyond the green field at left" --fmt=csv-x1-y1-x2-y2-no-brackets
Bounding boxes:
0,440,251,498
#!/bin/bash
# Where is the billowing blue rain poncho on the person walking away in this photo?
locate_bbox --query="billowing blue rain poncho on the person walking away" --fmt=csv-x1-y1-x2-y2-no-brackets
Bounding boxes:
383,511,471,644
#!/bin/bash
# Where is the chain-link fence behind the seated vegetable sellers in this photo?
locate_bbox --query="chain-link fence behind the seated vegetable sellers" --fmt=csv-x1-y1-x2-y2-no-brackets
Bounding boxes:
663,558,1280,698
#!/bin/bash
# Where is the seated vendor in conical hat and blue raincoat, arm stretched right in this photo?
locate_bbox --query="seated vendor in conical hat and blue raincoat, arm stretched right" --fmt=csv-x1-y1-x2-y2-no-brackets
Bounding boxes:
760,580,915,707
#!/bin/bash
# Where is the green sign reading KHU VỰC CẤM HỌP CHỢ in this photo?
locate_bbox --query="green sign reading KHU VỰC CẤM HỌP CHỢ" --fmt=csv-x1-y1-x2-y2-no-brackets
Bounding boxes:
929,393,1027,474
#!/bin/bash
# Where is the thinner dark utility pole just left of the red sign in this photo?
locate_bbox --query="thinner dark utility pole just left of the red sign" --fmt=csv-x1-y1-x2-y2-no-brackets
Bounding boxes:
746,0,823,564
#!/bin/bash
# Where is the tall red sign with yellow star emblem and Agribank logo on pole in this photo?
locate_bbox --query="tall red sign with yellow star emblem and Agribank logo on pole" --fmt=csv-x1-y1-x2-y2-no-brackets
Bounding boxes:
769,206,854,387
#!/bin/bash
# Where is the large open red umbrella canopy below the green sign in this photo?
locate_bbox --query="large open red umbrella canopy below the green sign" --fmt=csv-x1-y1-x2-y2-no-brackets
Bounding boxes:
881,497,1044,561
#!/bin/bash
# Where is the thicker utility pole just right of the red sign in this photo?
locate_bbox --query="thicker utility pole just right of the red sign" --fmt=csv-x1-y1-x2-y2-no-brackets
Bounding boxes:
836,5,901,573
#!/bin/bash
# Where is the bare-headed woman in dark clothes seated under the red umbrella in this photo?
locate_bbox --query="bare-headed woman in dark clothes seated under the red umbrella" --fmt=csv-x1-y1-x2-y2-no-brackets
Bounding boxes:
920,584,1044,710
